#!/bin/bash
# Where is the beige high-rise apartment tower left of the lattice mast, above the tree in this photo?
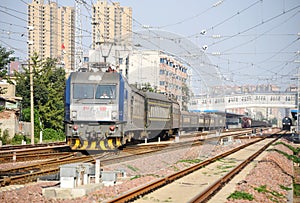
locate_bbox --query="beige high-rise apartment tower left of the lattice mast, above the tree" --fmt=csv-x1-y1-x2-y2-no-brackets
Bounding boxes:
27,0,75,73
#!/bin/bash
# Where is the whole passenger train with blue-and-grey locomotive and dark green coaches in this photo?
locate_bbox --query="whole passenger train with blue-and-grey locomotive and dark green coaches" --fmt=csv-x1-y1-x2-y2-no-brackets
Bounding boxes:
64,71,226,150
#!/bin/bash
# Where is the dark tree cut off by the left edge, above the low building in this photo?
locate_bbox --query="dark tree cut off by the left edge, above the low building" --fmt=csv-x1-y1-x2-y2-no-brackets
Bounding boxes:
0,45,15,94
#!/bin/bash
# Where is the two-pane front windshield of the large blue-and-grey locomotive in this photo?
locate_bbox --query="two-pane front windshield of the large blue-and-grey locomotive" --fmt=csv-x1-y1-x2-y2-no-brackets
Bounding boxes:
73,84,116,99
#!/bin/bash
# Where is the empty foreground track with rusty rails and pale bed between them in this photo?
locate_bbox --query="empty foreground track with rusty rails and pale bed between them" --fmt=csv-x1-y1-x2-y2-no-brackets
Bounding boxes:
108,129,284,202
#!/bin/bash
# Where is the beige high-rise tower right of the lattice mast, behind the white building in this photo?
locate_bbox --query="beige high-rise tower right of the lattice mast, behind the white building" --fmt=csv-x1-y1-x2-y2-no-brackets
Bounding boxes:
92,0,132,49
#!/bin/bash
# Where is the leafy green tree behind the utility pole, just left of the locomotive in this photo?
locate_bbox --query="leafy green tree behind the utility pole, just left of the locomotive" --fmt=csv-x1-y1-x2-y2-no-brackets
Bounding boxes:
15,54,65,136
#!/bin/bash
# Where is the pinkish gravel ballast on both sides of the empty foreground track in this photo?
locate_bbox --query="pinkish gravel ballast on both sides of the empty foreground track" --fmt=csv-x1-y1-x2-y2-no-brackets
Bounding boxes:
0,136,293,203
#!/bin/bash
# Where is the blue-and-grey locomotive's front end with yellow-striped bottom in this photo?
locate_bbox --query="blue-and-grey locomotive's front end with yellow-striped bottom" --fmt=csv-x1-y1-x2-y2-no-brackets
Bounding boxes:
65,72,124,151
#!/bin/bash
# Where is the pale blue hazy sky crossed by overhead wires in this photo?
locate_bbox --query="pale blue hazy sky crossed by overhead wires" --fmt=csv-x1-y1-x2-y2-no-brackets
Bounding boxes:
0,0,300,89
